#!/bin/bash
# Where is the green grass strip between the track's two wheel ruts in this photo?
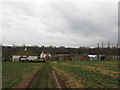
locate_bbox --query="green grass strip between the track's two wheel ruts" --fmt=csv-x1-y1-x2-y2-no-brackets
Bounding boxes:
34,62,56,88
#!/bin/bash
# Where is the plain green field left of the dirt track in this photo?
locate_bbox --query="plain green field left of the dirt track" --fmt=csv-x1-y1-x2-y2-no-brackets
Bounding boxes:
2,62,43,88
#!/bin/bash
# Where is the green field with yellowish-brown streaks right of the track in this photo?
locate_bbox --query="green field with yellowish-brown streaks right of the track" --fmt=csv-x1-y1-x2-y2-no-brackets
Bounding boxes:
52,61,120,88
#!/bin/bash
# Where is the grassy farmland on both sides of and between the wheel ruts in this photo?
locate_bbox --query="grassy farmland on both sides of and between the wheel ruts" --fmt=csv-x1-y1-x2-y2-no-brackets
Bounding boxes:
2,61,120,88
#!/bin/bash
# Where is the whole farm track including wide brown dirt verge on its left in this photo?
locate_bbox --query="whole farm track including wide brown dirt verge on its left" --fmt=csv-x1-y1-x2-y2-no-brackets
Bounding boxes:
15,63,66,88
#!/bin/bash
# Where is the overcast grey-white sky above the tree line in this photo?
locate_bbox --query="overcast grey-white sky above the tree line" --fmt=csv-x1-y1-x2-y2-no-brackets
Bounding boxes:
0,0,118,47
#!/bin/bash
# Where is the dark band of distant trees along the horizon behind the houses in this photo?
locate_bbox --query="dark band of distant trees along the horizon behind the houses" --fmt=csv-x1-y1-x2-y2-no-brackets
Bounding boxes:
2,42,120,60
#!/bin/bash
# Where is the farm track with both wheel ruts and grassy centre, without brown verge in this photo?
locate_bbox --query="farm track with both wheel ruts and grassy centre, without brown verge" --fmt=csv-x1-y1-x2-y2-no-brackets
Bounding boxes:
32,63,65,88
